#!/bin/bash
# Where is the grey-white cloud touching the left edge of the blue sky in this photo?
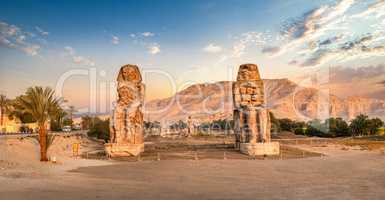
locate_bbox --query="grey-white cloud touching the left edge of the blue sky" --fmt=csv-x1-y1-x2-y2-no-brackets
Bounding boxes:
0,21,41,56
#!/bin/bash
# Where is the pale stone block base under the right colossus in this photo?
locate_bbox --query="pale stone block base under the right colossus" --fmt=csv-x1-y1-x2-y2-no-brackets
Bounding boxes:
240,142,280,156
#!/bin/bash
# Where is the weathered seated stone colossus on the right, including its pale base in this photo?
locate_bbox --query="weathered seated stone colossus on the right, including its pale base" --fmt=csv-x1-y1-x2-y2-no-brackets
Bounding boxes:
232,64,279,155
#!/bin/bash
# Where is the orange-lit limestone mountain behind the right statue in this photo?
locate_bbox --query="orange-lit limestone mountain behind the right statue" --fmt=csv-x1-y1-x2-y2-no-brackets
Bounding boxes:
145,79,385,121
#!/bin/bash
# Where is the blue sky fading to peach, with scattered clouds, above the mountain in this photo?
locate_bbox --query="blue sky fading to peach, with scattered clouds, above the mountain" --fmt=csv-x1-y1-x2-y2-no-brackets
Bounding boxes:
0,0,385,112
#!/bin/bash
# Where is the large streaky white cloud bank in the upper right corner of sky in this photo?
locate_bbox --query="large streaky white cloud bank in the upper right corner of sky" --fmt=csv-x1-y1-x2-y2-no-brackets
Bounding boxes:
255,0,385,67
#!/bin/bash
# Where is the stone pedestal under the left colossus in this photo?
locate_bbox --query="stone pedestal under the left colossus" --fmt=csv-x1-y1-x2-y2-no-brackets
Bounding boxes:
104,143,144,157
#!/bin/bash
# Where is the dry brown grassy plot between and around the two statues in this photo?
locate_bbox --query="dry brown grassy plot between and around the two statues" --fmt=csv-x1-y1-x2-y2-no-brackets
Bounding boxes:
98,136,322,161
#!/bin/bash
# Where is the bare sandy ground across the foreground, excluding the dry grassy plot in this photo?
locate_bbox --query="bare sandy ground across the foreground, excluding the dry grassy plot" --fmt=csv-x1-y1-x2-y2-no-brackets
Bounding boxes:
0,135,385,200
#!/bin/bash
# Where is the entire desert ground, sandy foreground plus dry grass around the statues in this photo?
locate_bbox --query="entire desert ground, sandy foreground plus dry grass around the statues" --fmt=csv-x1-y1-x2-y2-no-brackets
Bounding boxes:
0,132,385,200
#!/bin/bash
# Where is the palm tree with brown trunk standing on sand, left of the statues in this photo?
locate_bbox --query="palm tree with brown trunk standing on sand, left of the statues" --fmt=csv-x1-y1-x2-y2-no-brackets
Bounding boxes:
17,87,61,161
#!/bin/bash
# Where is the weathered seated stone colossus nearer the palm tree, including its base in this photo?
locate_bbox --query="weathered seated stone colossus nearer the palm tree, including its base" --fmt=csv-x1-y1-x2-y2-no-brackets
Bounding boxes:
105,65,145,157
